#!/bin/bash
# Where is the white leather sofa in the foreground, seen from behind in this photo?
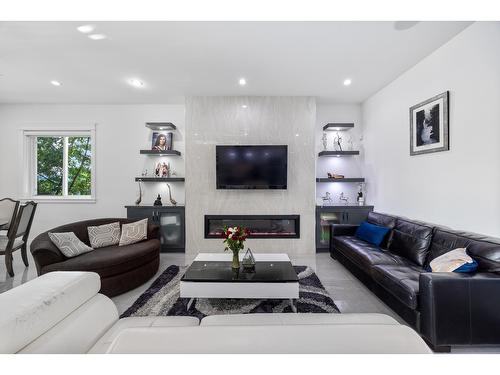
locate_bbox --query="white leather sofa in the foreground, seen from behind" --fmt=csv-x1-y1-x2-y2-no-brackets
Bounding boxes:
0,272,431,353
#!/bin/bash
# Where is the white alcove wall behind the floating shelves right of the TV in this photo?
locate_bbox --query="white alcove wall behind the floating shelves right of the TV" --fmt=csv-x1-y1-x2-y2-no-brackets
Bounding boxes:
315,103,364,204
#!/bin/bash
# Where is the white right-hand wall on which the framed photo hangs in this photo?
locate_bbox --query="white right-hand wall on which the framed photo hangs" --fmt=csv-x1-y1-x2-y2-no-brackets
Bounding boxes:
363,22,500,236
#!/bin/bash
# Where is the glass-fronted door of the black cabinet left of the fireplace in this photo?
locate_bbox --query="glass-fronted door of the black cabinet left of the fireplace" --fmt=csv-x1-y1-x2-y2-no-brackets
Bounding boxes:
155,210,184,251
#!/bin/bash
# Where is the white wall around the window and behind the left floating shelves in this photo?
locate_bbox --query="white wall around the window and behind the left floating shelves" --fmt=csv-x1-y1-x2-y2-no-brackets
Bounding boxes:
0,105,185,235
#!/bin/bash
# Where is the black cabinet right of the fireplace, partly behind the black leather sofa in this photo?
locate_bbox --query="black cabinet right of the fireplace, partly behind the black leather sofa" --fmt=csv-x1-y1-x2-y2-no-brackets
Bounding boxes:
316,206,373,252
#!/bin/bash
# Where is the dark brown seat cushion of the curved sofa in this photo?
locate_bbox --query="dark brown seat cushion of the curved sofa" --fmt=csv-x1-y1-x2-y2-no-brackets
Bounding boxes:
42,239,160,277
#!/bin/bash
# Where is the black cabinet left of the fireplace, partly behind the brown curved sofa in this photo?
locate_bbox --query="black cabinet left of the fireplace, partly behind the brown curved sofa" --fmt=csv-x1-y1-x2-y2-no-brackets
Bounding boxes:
125,206,186,253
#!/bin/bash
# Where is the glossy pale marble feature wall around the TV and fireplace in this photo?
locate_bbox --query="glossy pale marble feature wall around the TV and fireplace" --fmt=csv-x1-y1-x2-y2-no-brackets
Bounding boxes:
186,97,316,255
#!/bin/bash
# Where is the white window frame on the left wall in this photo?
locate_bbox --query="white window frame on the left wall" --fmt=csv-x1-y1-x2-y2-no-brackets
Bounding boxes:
21,124,96,203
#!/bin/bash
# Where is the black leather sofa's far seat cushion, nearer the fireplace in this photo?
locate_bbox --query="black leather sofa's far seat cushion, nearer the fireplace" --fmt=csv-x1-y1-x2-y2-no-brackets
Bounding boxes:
332,236,411,274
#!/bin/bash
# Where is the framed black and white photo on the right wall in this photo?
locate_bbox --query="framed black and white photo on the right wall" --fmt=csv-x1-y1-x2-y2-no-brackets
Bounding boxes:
410,91,450,155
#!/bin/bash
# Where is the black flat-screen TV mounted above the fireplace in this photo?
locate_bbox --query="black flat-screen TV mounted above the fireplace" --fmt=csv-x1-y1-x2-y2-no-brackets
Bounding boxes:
216,146,288,189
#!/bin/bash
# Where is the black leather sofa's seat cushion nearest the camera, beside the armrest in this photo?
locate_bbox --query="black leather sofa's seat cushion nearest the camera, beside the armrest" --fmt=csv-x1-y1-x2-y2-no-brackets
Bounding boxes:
372,264,422,310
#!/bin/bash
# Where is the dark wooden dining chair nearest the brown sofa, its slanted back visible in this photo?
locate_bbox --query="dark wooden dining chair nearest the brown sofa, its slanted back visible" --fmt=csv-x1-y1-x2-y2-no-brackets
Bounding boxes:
0,202,37,276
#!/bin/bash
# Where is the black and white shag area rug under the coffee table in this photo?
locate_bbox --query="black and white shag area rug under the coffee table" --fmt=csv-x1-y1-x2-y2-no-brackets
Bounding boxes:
121,266,340,319
